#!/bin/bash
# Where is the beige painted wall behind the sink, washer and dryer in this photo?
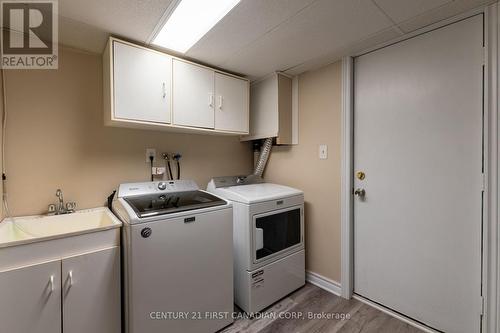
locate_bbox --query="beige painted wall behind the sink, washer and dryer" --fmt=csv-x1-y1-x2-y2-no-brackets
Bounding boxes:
0,44,340,281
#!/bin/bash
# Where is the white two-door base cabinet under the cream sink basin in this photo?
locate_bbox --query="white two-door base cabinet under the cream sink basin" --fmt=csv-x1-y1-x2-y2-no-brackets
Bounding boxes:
0,230,121,333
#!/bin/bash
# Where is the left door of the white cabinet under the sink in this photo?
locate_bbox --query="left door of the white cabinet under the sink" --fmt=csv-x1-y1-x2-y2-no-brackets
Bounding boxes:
0,260,61,333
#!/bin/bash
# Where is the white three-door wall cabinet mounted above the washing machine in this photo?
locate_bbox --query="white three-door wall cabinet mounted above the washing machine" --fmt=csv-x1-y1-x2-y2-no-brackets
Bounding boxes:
103,37,250,135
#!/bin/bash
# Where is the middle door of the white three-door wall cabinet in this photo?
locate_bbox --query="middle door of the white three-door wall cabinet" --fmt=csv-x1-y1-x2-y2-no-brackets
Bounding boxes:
172,59,215,128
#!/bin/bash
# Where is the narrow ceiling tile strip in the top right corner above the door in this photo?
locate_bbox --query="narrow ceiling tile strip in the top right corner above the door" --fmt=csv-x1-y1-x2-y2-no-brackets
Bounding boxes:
398,0,497,33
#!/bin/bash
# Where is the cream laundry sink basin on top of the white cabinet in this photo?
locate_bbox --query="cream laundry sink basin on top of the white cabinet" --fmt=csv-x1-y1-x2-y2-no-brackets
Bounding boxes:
0,208,121,247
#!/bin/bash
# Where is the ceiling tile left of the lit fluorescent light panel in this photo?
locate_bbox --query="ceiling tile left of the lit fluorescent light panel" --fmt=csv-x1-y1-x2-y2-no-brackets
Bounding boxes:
59,0,172,42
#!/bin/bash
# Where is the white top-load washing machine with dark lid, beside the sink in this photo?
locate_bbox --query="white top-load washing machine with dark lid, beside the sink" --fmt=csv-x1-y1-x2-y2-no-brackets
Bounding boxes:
113,180,234,333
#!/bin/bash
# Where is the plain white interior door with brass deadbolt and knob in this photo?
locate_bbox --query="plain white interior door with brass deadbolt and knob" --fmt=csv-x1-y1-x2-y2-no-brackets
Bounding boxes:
354,15,483,333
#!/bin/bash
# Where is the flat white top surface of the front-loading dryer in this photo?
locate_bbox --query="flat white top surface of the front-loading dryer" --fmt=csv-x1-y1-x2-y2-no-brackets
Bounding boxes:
214,183,303,204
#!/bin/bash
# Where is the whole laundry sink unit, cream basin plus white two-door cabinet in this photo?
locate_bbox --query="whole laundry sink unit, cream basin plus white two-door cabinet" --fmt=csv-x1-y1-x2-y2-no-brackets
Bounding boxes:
0,208,121,333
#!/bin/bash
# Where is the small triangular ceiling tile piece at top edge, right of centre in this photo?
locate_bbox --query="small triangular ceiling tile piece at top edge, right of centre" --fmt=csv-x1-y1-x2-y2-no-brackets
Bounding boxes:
374,0,453,23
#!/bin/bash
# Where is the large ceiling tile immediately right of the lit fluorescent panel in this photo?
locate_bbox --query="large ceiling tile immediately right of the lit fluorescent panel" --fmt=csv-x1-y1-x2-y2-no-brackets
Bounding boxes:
222,0,392,77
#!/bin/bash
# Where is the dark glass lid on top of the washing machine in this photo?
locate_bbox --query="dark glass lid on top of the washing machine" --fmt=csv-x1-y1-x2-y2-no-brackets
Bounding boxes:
123,190,226,218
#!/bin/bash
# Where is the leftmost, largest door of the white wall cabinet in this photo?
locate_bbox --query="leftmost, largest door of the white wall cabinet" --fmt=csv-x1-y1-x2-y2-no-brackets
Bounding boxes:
113,41,172,123
